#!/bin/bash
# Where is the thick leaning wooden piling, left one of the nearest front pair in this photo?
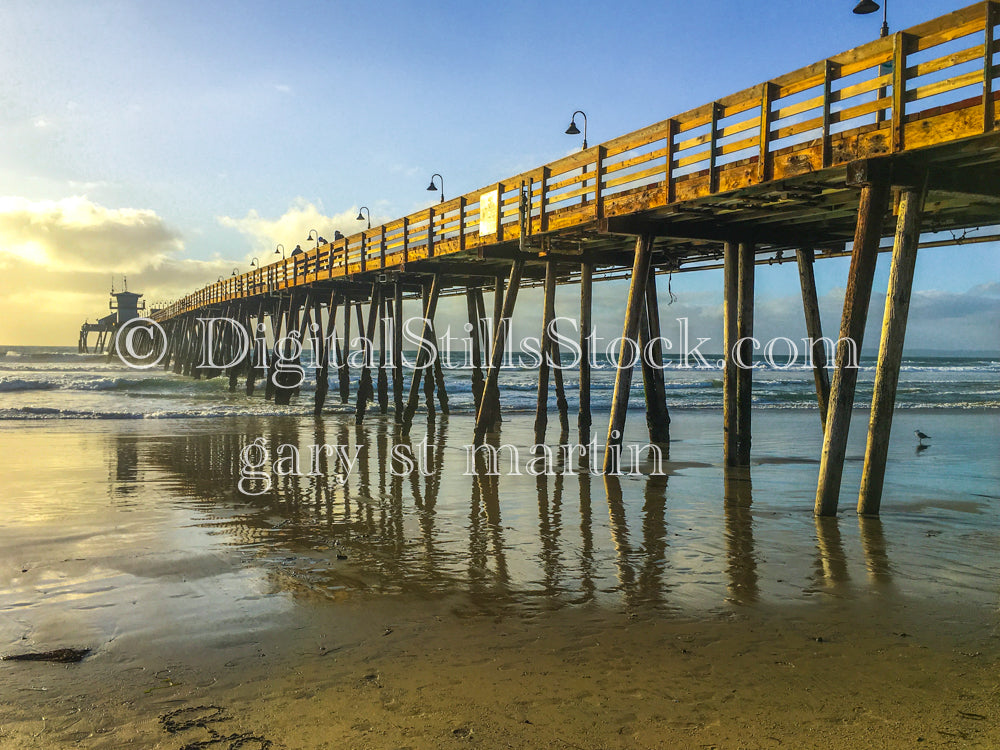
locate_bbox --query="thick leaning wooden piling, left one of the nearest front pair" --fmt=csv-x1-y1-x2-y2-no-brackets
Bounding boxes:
815,167,889,516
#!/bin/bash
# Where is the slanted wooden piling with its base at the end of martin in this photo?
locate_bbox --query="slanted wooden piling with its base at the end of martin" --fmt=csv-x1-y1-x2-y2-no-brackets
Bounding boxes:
604,234,653,474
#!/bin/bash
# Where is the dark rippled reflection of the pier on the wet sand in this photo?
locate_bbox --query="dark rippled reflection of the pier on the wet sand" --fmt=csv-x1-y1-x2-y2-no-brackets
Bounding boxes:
133,418,890,610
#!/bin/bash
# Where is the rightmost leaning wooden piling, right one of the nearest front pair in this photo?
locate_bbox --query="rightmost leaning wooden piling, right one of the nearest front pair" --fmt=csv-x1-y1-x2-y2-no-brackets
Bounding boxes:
858,190,921,516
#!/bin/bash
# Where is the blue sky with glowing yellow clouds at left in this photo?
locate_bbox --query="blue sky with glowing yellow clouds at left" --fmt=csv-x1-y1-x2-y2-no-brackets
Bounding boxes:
0,0,1000,353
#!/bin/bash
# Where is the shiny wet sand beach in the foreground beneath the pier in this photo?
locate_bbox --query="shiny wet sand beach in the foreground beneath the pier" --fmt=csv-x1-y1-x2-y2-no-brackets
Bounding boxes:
0,412,1000,749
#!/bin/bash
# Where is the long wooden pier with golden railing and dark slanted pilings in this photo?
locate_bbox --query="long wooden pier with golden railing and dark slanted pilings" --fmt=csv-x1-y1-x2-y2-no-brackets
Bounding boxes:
146,2,1000,516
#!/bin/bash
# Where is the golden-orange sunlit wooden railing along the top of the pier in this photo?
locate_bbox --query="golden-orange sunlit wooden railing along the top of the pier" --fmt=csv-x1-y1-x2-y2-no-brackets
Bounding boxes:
156,0,1000,319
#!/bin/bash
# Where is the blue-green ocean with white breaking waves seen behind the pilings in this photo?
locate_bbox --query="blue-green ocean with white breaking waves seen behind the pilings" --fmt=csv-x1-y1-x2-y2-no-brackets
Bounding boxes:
0,347,1000,420
